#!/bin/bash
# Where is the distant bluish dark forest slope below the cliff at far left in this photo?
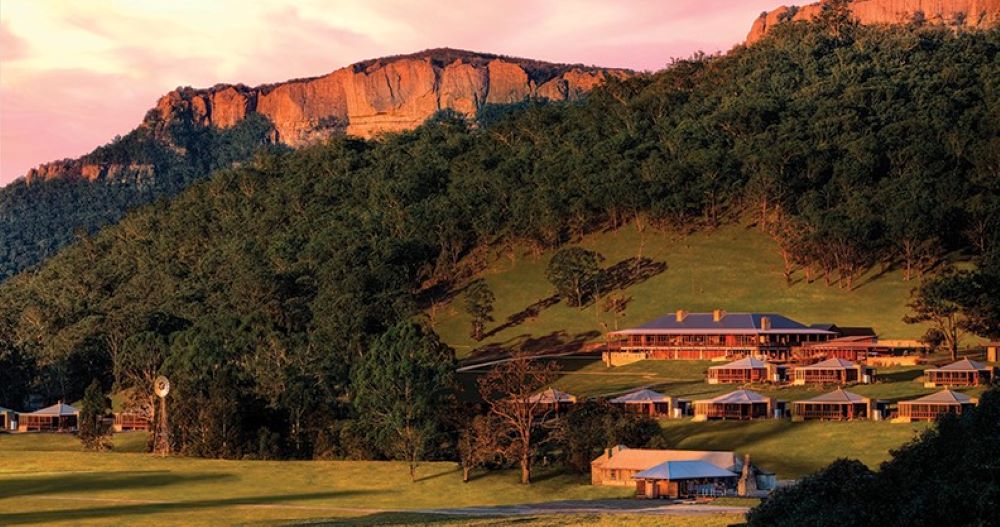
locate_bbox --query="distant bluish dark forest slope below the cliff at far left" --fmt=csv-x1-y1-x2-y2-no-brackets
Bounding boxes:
0,112,272,281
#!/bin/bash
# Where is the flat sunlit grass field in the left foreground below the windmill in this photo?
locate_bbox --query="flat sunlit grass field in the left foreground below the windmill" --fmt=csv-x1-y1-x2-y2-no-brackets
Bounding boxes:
0,433,739,527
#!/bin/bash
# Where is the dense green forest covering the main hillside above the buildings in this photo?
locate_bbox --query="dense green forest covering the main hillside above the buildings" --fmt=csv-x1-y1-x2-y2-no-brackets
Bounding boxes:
0,13,1000,457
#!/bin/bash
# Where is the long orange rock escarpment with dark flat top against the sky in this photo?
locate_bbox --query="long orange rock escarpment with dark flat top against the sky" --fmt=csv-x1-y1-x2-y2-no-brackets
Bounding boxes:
147,49,628,146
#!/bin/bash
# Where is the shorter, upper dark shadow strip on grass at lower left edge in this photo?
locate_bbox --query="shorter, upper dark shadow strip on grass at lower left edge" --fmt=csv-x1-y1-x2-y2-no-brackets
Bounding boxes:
0,470,233,498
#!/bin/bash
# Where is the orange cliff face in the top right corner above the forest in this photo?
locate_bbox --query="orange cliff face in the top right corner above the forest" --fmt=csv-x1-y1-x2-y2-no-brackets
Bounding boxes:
746,0,1000,45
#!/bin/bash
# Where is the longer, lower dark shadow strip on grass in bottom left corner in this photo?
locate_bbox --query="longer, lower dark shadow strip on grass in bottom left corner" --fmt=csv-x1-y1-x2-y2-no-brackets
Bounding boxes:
0,489,368,525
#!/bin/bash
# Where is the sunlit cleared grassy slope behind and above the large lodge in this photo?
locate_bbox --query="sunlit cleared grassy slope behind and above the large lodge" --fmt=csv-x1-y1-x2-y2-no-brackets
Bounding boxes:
434,226,923,356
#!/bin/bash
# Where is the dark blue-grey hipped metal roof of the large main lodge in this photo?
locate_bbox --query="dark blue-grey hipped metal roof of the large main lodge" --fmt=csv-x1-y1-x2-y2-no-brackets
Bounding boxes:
613,313,836,335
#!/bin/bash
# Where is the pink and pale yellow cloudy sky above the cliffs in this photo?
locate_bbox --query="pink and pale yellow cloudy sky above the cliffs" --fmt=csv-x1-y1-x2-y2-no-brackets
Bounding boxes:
0,0,782,185
